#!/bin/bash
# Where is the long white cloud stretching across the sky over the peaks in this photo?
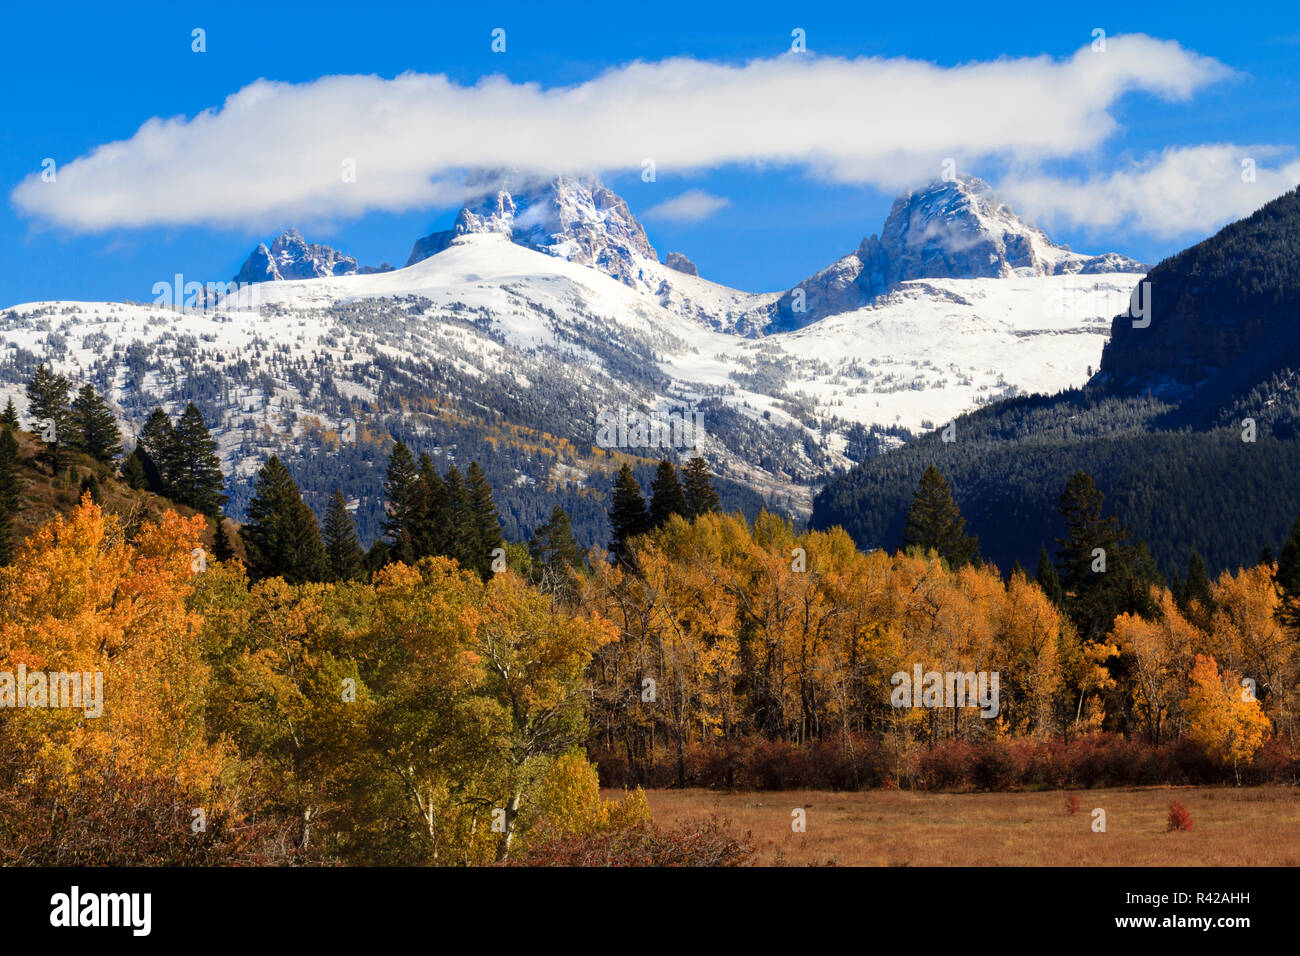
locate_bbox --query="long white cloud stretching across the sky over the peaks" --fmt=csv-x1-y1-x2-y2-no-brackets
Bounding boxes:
12,35,1230,232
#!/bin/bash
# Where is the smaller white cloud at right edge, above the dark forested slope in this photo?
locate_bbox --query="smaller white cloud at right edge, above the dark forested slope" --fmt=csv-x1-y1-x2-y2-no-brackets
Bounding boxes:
997,143,1300,239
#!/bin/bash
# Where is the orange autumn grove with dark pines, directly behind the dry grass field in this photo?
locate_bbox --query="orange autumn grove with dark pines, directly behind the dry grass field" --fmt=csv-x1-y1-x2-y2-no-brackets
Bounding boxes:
581,463,1300,786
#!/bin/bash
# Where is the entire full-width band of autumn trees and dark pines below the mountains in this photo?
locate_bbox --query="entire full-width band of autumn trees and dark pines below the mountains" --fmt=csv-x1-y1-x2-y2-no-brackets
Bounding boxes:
0,371,1300,865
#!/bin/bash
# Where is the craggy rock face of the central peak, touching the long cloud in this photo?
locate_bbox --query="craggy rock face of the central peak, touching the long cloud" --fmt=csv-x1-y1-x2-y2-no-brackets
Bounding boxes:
407,176,658,286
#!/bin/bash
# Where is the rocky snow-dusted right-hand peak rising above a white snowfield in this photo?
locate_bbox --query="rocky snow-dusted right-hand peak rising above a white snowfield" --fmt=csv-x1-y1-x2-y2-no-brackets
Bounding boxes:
772,176,1147,329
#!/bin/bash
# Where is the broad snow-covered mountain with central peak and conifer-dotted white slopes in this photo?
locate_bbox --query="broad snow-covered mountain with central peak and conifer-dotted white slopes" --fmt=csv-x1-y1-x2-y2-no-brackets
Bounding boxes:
0,177,1140,546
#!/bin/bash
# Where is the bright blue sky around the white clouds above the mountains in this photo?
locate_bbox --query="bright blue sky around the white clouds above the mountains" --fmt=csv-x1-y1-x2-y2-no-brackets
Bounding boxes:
0,3,1300,304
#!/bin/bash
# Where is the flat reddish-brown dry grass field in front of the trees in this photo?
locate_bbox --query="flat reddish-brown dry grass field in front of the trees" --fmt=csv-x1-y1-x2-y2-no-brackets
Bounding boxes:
634,787,1300,866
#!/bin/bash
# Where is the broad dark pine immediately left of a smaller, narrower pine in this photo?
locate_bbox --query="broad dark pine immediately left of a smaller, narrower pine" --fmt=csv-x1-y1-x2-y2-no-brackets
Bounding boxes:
241,455,328,584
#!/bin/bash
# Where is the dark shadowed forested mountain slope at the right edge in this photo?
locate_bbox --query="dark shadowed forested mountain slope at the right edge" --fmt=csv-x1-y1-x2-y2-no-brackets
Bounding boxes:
813,184,1300,574
